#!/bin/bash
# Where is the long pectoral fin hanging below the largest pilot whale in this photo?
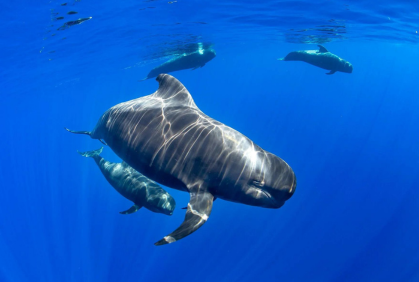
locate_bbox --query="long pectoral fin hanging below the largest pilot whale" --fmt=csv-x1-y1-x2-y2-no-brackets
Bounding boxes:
154,188,214,246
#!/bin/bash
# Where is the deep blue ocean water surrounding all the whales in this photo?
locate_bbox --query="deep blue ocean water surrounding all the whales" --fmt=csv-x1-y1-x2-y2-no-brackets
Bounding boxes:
0,0,419,281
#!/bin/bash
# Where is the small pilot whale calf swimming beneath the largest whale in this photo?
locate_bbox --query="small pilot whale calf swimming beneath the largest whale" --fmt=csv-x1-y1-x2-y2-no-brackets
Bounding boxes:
79,148,176,215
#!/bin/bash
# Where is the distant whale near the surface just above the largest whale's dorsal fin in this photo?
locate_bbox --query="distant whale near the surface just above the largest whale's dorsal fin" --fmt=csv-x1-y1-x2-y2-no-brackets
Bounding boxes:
140,49,216,81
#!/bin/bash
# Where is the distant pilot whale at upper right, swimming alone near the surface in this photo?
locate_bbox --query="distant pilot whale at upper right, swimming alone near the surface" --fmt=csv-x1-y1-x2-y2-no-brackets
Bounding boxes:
279,45,353,74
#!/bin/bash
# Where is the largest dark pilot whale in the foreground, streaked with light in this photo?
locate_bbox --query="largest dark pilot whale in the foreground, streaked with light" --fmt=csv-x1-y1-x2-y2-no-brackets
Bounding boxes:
65,74,297,245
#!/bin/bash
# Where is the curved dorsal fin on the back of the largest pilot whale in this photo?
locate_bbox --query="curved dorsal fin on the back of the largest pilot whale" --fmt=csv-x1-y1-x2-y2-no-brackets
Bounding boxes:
152,74,198,108
